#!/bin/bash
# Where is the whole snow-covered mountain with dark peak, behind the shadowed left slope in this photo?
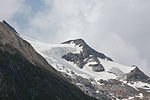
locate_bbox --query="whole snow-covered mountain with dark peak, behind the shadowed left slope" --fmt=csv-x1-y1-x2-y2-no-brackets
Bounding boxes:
23,37,150,100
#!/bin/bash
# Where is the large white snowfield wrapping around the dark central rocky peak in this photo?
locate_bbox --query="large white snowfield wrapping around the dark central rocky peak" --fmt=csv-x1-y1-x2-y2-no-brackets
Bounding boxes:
23,37,135,80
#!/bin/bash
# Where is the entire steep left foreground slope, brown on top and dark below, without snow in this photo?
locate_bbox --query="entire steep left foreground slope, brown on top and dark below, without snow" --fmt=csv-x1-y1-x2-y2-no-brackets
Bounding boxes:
0,21,95,100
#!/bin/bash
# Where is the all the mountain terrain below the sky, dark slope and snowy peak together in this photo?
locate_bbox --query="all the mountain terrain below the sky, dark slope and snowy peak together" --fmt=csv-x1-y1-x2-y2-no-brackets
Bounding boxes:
0,21,150,100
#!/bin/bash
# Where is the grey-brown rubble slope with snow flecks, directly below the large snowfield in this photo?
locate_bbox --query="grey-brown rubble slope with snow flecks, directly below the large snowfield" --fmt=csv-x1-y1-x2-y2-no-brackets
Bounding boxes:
62,73,140,100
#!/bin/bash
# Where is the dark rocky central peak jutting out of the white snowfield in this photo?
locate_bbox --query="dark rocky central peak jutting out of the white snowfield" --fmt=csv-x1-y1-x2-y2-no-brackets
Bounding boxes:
62,39,113,72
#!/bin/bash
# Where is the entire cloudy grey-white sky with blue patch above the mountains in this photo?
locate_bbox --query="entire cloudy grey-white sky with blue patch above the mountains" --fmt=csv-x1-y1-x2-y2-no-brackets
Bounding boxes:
0,0,150,76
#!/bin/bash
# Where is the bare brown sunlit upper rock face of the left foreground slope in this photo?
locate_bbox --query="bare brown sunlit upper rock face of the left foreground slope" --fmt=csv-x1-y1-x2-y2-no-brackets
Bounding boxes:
0,22,49,68
